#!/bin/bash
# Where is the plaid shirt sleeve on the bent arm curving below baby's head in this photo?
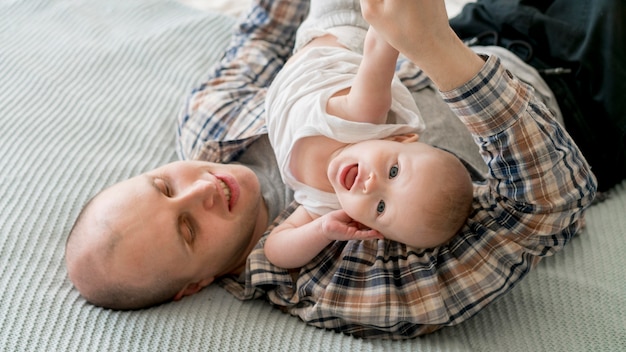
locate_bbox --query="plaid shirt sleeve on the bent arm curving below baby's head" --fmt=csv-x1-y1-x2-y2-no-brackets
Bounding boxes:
222,56,596,339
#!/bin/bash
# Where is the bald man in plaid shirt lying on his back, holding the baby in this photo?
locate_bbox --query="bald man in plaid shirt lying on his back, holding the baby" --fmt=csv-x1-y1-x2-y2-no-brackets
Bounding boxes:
66,0,596,338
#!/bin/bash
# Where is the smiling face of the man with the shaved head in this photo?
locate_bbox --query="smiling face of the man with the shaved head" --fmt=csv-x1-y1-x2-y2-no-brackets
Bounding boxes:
85,161,267,294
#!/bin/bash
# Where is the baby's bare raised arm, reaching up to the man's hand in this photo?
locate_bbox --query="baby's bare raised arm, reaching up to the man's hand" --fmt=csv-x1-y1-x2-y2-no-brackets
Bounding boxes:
327,27,398,124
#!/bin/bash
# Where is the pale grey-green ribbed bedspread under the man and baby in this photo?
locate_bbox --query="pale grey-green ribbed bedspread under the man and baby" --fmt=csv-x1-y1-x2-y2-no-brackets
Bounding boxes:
0,0,626,352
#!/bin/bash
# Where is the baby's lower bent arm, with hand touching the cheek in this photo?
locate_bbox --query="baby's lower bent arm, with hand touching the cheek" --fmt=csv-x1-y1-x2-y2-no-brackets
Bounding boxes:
264,206,382,269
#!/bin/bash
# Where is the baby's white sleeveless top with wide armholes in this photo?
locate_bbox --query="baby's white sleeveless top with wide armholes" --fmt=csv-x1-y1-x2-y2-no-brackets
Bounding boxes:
265,47,424,215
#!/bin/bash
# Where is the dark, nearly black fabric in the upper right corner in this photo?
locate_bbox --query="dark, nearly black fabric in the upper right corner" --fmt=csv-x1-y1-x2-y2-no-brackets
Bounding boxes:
450,0,626,191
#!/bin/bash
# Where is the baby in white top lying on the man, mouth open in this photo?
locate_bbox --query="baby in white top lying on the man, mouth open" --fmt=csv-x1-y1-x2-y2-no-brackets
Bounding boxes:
265,0,473,268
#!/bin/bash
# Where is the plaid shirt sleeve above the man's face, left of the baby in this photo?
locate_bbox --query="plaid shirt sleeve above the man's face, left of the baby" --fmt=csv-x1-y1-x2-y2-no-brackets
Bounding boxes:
177,0,309,163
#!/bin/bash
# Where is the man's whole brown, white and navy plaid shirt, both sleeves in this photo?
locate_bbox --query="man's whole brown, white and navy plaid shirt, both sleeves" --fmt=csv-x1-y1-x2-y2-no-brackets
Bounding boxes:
179,1,596,339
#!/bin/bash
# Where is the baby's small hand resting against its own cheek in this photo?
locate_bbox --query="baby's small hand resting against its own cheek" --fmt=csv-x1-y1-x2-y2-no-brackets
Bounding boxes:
320,210,384,241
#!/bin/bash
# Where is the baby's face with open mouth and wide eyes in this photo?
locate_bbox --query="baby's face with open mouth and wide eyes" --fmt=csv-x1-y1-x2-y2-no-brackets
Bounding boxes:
327,139,450,242
